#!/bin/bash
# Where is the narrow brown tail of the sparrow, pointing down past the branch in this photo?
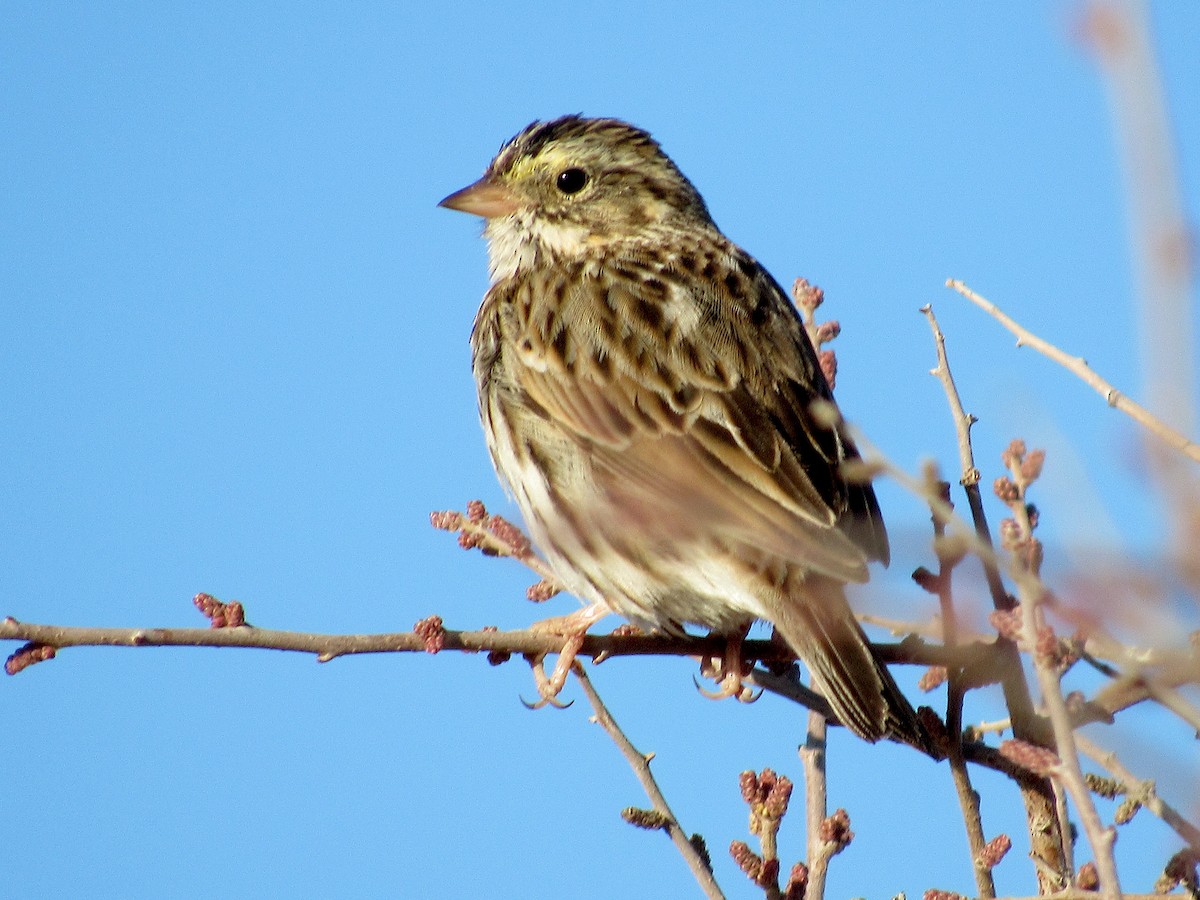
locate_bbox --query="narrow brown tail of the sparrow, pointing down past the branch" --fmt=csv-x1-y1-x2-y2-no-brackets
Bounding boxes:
773,575,930,749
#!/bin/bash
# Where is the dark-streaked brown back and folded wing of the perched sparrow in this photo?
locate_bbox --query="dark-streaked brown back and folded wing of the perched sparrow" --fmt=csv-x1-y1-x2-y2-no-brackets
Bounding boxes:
500,242,887,581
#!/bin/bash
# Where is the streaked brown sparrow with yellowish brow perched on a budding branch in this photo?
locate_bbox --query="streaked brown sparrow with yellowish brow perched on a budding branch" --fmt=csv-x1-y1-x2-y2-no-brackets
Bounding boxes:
442,115,918,740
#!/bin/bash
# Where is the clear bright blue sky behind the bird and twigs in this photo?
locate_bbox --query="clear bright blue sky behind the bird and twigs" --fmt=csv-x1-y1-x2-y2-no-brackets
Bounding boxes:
0,0,1200,898
